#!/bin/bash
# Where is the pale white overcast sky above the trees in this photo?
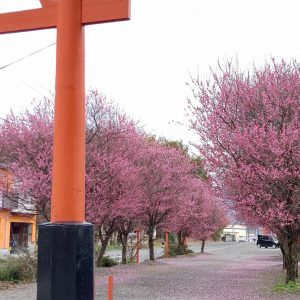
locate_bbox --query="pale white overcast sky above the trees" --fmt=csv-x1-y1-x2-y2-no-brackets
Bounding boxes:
0,0,300,142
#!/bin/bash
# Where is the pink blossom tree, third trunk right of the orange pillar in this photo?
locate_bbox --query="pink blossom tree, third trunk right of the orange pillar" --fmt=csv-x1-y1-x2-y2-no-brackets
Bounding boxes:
134,140,195,260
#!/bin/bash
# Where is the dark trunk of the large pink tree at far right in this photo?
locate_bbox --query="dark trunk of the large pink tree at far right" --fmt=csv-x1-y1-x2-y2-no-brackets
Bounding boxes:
281,235,298,283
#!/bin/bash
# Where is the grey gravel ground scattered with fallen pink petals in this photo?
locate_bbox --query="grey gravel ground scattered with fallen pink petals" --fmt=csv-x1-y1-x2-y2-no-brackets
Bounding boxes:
0,243,300,300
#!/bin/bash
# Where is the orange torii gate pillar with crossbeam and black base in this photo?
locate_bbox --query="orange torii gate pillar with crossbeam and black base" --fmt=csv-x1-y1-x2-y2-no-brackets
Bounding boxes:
0,0,130,300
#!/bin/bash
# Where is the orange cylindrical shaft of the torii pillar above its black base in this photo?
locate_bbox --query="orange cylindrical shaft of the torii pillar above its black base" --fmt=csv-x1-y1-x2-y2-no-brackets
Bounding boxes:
51,0,85,222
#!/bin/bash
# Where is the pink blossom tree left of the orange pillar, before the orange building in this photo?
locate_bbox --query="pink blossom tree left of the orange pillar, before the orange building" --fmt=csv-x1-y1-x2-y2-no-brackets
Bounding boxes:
0,99,53,221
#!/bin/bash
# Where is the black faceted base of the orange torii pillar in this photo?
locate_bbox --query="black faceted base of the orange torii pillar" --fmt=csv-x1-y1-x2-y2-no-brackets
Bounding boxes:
37,223,94,300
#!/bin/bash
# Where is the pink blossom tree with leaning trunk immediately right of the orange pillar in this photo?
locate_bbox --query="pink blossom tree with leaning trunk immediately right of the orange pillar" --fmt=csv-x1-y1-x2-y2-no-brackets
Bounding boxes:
86,144,141,265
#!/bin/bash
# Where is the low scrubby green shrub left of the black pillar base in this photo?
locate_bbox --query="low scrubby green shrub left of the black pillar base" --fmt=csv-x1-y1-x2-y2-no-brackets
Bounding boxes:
0,256,37,282
